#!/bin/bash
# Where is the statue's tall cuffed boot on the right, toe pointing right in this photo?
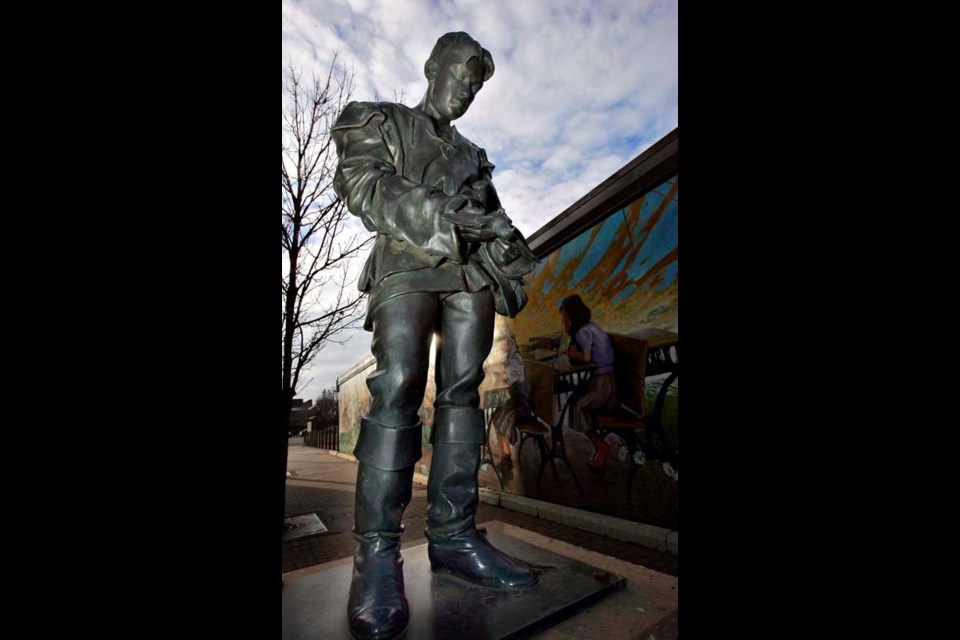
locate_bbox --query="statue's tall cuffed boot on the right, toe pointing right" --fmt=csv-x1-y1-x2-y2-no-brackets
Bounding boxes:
426,407,537,590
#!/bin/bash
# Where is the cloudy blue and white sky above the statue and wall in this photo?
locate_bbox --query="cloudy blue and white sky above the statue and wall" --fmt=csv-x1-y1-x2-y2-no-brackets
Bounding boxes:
281,0,679,399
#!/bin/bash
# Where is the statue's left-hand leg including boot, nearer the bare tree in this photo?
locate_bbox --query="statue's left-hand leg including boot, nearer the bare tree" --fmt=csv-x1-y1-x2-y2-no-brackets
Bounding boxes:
347,293,438,640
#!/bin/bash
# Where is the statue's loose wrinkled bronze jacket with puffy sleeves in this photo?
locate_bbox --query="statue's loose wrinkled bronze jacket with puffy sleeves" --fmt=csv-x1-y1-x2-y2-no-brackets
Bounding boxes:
331,102,529,330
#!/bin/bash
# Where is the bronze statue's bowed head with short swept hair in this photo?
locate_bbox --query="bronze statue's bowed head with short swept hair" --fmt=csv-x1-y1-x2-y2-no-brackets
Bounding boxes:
423,31,494,122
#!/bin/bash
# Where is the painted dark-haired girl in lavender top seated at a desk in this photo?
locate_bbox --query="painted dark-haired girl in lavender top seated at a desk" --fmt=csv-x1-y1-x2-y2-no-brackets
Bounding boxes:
560,294,620,471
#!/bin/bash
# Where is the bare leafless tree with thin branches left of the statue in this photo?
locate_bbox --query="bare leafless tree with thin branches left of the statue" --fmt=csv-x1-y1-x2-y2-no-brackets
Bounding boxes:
280,56,373,536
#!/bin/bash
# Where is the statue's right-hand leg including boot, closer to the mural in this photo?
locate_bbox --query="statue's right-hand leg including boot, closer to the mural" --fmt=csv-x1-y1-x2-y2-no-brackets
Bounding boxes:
426,291,537,589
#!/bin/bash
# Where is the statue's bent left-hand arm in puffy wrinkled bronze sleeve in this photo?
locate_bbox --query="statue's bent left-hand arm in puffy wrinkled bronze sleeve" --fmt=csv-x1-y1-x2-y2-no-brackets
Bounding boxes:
331,102,463,262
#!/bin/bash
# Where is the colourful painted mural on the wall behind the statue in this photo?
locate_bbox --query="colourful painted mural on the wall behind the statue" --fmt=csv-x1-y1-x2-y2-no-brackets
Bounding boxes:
339,176,679,530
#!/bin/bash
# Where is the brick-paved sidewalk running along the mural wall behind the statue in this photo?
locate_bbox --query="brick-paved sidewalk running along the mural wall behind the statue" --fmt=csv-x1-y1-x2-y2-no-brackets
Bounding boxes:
282,438,679,576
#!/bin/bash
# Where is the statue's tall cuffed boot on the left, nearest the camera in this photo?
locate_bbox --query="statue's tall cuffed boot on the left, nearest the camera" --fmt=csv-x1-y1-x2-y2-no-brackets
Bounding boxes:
347,418,421,640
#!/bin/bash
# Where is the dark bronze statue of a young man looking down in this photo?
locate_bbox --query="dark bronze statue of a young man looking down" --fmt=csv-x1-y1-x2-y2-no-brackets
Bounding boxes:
332,32,537,640
